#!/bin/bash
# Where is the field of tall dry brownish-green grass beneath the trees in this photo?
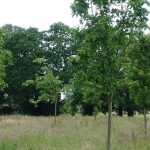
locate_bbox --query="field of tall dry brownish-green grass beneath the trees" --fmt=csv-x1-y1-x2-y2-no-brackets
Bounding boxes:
0,115,150,150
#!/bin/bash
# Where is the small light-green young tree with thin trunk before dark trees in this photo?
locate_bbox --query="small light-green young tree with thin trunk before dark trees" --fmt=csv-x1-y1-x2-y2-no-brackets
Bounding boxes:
23,58,61,118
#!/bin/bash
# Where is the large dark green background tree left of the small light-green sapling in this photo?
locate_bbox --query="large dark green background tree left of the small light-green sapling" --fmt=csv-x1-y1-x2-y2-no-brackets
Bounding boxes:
3,27,44,112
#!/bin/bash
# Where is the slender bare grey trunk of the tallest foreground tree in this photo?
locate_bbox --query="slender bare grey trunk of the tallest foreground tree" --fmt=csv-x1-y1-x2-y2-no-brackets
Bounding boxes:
106,100,112,150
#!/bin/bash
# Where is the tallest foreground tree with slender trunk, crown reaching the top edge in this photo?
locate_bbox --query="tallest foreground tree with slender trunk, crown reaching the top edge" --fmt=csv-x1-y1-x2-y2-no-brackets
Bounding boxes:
72,0,148,150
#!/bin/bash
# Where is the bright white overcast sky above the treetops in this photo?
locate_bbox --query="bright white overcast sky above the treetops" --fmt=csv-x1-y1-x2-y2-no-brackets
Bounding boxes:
0,0,79,30
